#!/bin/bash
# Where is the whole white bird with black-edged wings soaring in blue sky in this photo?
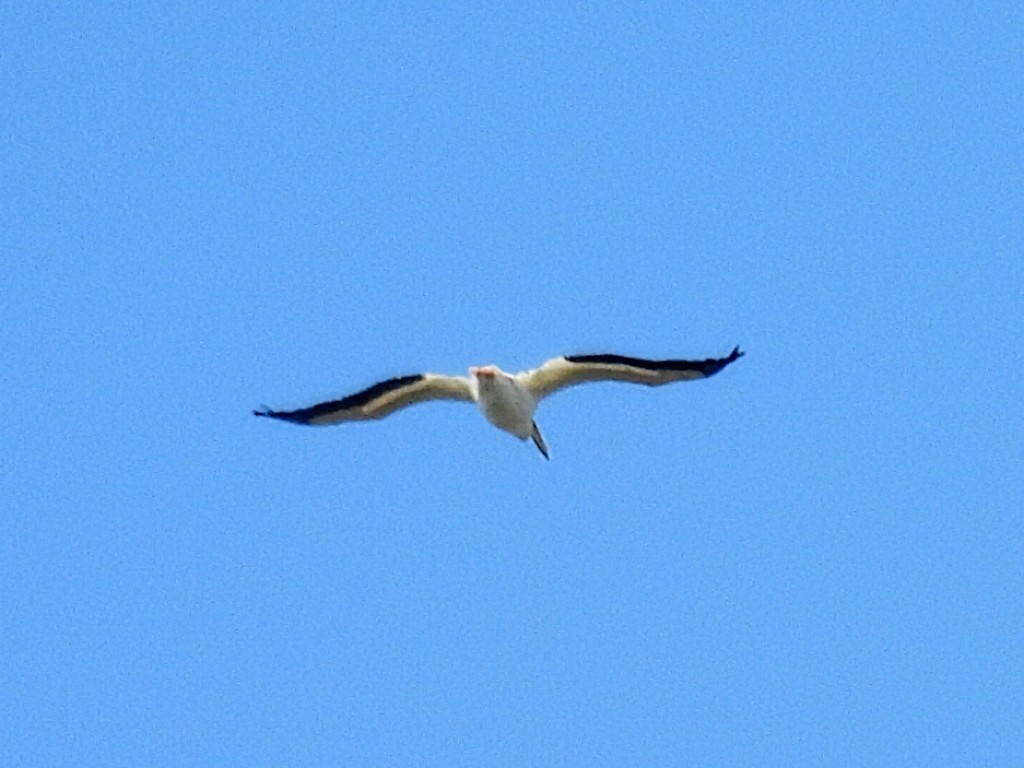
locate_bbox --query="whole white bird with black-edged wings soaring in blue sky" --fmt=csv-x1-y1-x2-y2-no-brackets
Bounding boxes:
253,346,743,459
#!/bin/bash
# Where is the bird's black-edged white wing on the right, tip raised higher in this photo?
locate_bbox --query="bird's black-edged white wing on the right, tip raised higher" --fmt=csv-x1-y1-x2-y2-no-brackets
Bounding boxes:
516,346,743,399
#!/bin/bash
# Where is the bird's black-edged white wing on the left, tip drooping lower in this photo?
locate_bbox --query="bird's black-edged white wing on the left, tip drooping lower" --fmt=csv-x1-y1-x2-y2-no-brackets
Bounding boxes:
253,374,473,426
